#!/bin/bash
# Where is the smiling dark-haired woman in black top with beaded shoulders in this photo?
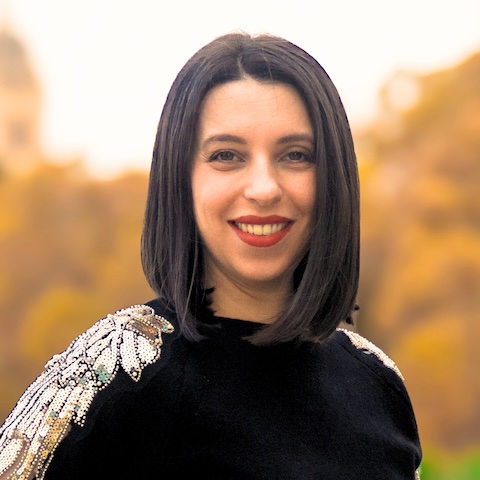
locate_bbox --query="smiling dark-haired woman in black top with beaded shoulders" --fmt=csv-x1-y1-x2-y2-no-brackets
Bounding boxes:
0,33,421,480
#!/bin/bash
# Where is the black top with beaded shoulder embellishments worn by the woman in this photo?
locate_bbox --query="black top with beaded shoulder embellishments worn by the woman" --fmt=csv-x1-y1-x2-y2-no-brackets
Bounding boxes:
0,301,421,480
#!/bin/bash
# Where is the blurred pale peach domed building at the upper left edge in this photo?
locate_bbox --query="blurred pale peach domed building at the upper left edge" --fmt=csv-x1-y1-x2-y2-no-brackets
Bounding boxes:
0,27,41,176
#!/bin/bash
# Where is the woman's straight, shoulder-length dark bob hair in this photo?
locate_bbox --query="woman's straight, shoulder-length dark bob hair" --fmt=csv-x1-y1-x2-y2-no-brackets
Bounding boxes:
142,33,360,345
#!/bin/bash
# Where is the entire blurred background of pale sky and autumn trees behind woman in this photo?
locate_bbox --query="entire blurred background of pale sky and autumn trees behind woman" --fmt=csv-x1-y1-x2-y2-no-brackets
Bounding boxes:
0,0,480,480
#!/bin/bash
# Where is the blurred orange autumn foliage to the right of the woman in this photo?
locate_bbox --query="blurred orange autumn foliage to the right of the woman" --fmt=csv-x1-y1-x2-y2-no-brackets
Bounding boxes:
357,54,480,451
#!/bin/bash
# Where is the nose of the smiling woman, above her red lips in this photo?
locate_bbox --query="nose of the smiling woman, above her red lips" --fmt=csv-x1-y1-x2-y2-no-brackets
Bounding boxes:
245,158,282,205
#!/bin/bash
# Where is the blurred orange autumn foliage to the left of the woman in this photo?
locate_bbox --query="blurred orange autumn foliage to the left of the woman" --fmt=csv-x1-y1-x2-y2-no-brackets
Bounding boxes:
0,164,153,419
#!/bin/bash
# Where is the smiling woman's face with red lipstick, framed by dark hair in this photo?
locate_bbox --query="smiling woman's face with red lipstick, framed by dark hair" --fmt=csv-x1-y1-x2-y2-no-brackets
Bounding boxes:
192,78,315,289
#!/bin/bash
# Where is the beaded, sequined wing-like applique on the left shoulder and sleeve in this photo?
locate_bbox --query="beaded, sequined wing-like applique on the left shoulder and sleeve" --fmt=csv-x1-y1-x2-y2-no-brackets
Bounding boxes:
0,305,174,480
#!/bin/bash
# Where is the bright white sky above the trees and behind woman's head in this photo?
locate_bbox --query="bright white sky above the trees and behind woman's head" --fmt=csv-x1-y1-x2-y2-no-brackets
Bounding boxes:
0,0,480,178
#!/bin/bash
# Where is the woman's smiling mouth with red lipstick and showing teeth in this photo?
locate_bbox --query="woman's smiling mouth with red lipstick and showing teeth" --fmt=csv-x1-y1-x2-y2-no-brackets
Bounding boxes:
229,215,294,247
